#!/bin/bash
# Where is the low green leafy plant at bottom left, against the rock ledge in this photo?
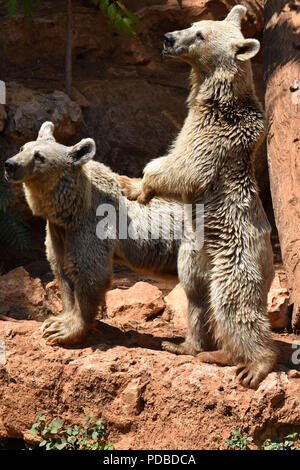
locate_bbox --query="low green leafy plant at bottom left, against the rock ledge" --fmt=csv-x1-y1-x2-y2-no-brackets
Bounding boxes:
26,411,114,450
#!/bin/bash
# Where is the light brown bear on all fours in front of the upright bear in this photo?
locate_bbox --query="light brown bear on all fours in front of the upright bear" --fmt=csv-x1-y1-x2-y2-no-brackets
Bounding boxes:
5,122,188,344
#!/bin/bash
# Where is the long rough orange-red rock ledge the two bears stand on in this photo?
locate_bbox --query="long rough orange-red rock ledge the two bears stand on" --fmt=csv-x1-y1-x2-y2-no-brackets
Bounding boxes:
0,321,300,450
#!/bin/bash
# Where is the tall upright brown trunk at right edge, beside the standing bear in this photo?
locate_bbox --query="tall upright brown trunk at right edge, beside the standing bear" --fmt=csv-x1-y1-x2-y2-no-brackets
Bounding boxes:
264,0,300,330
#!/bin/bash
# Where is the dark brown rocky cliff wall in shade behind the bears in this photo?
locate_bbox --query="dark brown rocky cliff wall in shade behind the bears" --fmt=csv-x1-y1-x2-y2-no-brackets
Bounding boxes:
0,0,268,198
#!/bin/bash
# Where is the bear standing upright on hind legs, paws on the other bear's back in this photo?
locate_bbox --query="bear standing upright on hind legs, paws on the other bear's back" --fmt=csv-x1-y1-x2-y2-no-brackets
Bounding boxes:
119,5,277,388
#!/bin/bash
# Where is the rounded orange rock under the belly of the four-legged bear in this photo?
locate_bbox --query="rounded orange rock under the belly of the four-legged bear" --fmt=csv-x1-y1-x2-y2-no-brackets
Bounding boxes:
106,281,165,320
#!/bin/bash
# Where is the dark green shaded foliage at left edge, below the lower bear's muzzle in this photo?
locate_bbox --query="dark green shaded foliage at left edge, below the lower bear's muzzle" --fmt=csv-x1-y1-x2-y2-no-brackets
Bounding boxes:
0,175,30,251
